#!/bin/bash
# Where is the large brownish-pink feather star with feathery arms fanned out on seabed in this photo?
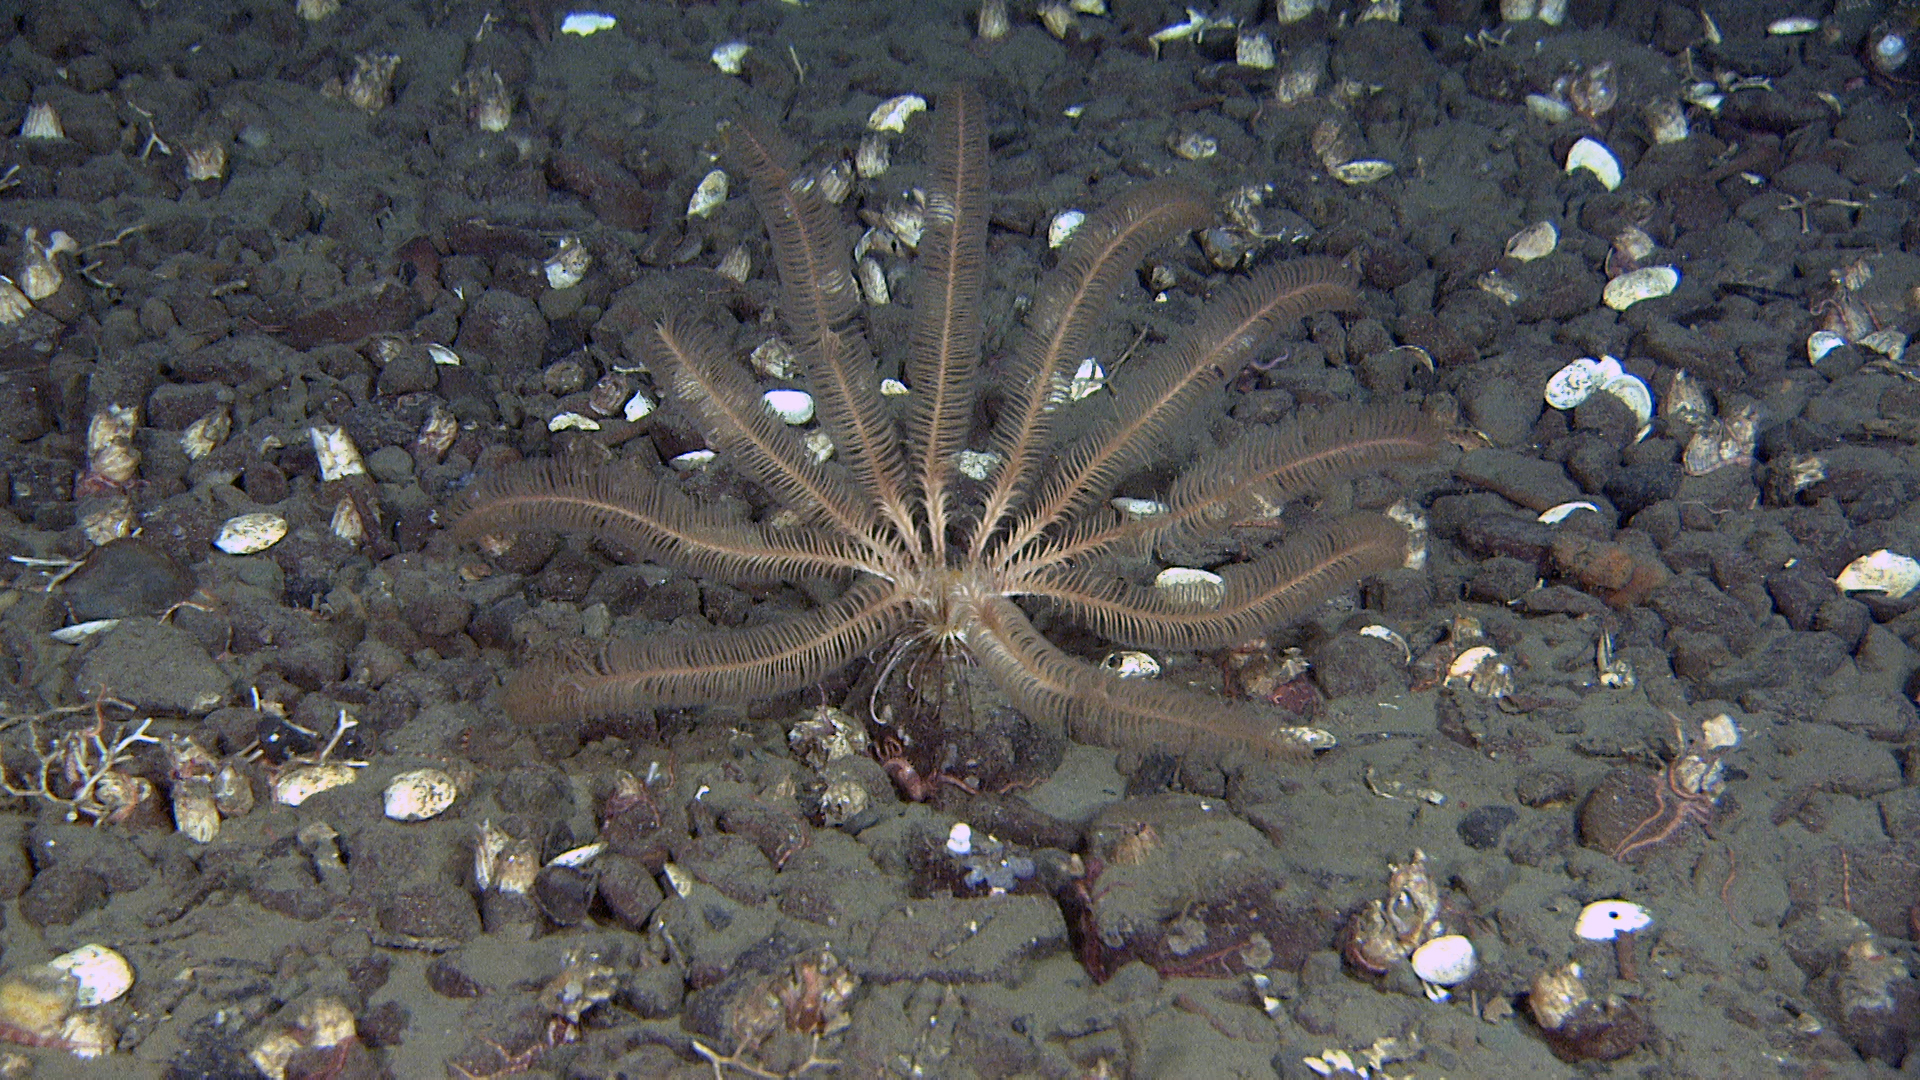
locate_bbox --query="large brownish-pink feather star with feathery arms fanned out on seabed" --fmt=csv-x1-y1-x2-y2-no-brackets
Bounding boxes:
453,90,1438,776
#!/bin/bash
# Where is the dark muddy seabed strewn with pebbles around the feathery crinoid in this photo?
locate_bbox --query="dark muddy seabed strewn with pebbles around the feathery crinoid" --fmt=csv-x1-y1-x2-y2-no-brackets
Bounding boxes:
0,0,1920,1078
